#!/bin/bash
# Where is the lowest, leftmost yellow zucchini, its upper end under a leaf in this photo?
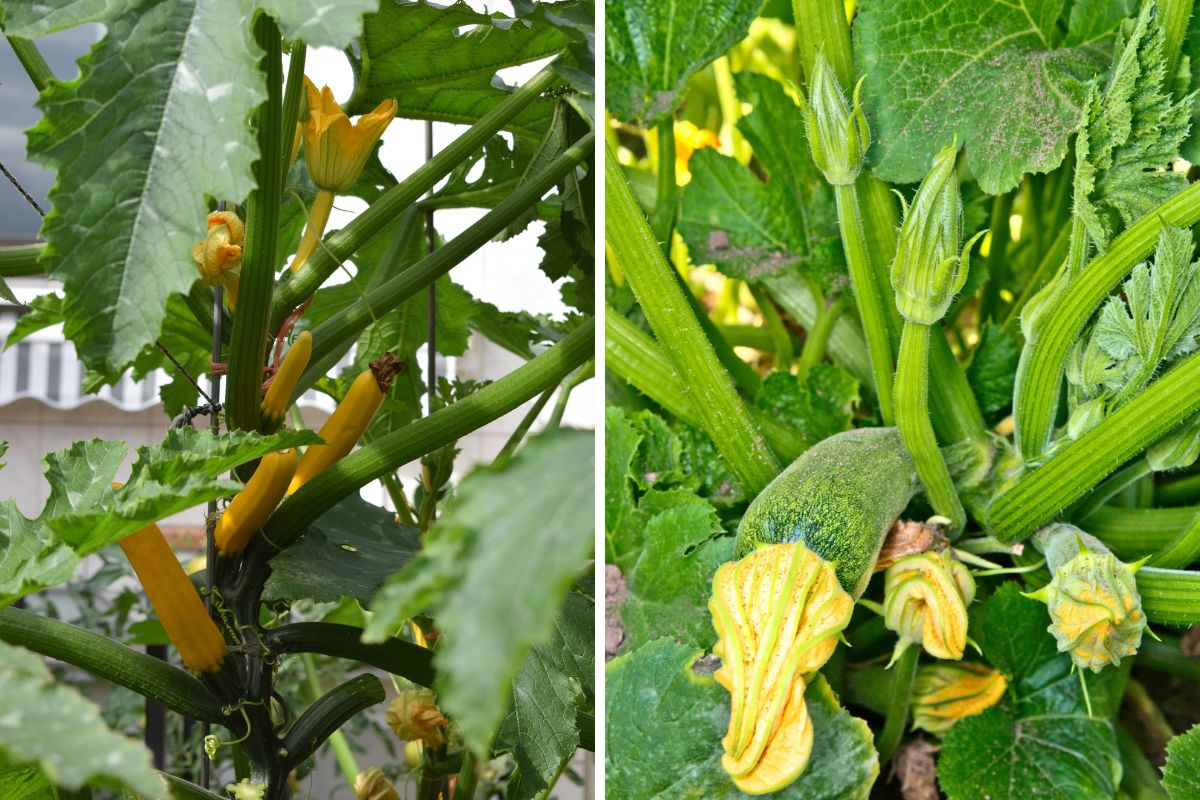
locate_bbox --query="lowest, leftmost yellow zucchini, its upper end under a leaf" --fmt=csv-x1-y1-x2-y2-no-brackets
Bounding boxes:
121,523,226,672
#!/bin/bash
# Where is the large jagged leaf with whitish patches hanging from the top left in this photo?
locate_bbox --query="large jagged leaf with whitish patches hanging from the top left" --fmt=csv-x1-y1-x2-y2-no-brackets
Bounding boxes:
6,0,376,379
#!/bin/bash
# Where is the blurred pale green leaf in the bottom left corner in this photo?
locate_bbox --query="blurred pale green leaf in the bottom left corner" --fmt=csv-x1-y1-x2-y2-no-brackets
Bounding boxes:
0,643,169,798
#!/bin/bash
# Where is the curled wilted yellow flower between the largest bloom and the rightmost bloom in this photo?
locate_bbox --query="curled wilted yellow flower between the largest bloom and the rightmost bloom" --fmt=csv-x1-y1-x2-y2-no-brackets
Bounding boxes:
883,551,974,661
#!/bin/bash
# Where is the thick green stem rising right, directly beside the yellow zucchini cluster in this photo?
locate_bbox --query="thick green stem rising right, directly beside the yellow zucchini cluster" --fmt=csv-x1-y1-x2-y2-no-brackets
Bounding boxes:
267,318,595,549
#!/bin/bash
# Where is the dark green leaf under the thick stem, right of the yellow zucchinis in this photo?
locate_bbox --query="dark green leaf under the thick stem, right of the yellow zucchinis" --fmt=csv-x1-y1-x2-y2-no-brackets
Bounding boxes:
263,494,421,606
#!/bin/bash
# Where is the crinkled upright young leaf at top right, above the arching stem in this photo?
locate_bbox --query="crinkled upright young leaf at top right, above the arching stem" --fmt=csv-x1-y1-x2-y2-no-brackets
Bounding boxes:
1074,2,1195,252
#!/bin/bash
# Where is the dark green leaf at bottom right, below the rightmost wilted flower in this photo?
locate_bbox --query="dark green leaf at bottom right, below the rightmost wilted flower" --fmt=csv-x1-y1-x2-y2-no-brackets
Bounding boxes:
937,581,1121,800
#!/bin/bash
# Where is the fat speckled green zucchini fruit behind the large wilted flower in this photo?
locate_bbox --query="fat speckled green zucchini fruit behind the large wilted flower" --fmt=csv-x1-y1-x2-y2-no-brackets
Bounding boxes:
736,428,919,600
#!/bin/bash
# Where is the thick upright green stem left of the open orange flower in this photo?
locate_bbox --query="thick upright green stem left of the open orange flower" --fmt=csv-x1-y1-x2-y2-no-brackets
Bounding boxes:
224,14,283,431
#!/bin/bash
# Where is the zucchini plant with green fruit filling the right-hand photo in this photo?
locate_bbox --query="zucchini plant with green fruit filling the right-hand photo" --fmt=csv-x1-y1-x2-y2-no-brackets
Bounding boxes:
605,0,1200,800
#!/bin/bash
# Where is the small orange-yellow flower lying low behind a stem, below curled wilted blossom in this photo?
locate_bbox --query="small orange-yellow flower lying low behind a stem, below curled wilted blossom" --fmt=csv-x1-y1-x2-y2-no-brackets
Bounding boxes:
912,661,1008,736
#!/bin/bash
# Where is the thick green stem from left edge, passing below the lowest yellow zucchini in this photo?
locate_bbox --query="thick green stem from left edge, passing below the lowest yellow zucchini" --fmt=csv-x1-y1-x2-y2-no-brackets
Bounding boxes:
0,607,226,724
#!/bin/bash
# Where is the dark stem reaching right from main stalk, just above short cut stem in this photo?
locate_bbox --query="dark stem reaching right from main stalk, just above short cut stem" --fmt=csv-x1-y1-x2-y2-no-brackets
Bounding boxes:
268,622,434,686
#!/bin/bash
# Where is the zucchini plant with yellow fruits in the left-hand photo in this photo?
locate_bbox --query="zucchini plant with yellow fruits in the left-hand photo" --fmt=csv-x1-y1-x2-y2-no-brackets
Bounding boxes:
0,0,596,800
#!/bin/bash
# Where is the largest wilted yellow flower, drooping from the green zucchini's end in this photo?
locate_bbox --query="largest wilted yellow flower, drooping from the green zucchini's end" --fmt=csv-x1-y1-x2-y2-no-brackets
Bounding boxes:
708,542,854,794
